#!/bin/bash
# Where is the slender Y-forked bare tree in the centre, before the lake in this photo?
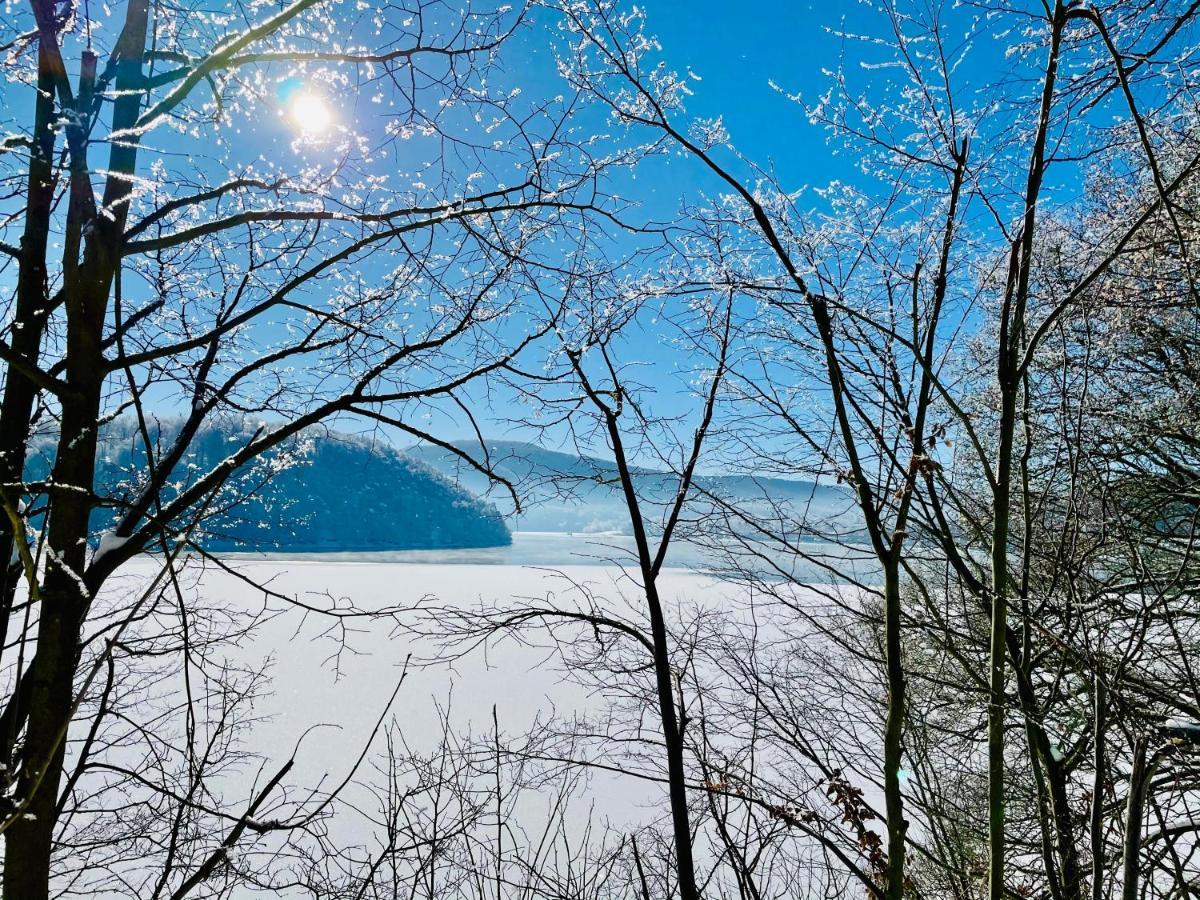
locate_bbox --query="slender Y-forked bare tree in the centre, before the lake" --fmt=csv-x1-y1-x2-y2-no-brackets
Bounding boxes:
417,259,737,900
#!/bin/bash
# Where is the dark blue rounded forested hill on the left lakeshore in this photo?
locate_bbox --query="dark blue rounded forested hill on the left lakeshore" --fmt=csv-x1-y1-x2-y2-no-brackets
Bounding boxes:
26,420,512,552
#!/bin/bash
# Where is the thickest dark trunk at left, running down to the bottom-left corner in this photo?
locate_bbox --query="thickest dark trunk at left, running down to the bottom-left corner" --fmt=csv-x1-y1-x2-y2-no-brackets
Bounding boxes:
4,0,149,900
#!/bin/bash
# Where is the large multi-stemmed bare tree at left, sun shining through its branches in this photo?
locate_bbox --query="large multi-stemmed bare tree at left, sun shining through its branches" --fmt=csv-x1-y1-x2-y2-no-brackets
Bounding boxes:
0,0,638,899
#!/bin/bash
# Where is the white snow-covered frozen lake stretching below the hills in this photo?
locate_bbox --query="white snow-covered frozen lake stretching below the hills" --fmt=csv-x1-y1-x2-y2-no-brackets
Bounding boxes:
77,533,883,897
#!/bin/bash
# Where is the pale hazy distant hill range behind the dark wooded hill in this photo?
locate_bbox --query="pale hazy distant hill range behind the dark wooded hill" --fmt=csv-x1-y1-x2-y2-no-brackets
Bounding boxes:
404,440,862,538
